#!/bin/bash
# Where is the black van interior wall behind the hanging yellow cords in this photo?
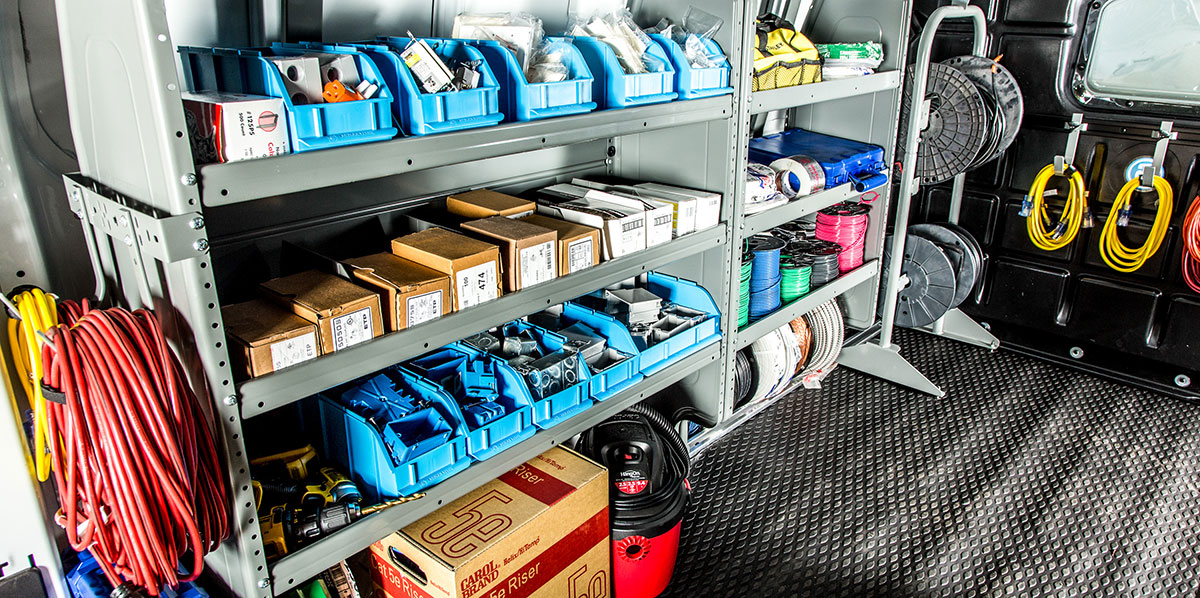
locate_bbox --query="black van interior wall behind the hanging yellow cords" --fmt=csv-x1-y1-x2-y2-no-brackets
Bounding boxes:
912,0,1200,399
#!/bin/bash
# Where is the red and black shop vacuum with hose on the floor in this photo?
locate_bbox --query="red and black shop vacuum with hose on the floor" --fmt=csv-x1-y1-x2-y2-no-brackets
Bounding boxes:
578,405,691,598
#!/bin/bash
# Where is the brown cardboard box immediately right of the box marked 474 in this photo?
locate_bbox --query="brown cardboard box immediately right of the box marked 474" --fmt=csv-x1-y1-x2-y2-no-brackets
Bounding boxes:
462,216,558,293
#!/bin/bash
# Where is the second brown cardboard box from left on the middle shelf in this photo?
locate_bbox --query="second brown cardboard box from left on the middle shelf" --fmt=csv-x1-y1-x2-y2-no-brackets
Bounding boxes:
263,270,383,353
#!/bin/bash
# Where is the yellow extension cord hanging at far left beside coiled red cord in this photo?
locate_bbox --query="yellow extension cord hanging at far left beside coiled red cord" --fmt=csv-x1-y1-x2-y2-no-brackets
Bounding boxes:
8,288,59,482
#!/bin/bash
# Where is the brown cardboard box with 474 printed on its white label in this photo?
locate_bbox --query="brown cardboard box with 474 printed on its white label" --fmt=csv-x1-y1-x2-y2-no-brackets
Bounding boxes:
391,228,500,311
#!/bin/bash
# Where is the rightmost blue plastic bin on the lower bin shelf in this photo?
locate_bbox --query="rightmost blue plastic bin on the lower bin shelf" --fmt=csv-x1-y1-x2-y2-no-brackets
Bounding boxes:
641,271,721,376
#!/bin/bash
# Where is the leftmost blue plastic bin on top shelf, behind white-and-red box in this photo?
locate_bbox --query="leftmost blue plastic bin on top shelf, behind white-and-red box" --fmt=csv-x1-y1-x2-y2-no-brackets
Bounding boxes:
179,44,397,153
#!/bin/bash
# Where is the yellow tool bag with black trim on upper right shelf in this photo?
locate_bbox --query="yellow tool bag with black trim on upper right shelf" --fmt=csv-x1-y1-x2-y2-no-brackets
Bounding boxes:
754,13,821,91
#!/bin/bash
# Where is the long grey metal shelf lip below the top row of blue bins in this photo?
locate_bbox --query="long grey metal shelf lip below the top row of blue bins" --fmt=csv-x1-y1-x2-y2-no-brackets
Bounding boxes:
200,96,733,208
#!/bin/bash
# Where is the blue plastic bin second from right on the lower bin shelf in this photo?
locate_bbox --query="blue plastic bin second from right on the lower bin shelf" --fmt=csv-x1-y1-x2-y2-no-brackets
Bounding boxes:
560,303,644,401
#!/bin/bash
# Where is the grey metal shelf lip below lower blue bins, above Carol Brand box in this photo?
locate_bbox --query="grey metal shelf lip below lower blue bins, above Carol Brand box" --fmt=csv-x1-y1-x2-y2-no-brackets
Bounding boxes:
270,341,721,594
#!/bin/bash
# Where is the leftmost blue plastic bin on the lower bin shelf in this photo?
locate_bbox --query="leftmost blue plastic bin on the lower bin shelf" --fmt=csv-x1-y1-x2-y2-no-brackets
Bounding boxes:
306,367,472,502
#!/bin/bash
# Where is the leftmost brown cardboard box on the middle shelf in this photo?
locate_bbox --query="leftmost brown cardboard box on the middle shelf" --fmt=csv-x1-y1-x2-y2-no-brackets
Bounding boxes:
221,299,320,378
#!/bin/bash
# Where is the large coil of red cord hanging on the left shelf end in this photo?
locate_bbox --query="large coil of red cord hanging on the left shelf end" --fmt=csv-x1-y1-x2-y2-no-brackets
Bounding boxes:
42,301,230,596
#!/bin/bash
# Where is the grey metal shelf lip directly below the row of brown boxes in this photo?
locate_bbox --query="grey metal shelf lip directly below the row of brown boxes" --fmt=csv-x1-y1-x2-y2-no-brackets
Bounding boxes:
238,223,726,418
